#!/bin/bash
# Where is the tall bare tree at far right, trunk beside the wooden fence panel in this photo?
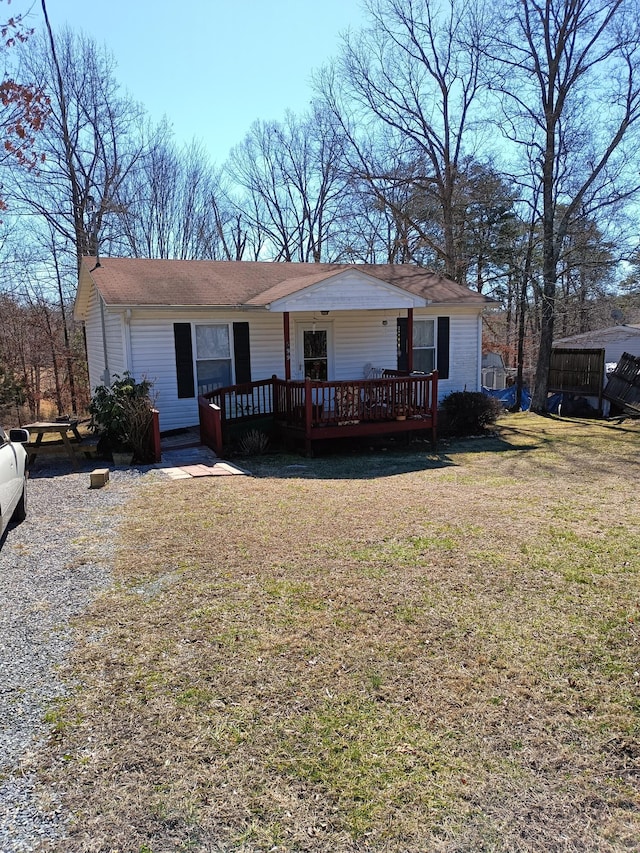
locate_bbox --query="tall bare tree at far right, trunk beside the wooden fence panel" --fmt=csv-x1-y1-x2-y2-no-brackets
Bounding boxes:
488,0,640,413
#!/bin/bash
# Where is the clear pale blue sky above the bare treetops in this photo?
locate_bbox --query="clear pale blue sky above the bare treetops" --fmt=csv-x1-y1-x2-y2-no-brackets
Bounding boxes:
43,0,363,165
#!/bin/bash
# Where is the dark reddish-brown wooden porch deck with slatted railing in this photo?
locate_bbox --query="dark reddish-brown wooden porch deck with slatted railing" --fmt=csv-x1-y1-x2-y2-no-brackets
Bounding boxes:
198,370,438,454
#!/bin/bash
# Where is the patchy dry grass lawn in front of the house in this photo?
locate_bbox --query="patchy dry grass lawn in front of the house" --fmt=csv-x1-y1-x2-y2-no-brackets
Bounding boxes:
40,415,640,853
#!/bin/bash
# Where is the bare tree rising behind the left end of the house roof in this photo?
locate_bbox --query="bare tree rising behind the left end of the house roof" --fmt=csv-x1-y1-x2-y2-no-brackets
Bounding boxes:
8,18,144,278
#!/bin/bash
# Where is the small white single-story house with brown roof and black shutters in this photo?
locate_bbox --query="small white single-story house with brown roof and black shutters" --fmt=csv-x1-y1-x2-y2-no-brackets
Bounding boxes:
75,258,492,431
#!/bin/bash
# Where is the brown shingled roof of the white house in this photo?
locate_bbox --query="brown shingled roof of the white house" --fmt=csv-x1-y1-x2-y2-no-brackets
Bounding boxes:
76,258,493,316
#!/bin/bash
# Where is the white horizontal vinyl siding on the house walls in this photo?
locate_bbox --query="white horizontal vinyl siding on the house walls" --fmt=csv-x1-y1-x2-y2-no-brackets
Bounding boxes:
92,302,481,431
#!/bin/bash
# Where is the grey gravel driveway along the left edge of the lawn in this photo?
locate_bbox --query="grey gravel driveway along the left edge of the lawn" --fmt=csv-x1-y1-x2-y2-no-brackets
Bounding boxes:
0,461,155,853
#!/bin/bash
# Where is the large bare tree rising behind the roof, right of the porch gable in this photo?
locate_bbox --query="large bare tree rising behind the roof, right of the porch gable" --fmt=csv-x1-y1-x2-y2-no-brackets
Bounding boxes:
318,0,490,282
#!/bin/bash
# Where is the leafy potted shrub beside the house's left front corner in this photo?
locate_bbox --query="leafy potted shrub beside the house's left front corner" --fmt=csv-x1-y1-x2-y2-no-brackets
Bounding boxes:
89,371,154,465
